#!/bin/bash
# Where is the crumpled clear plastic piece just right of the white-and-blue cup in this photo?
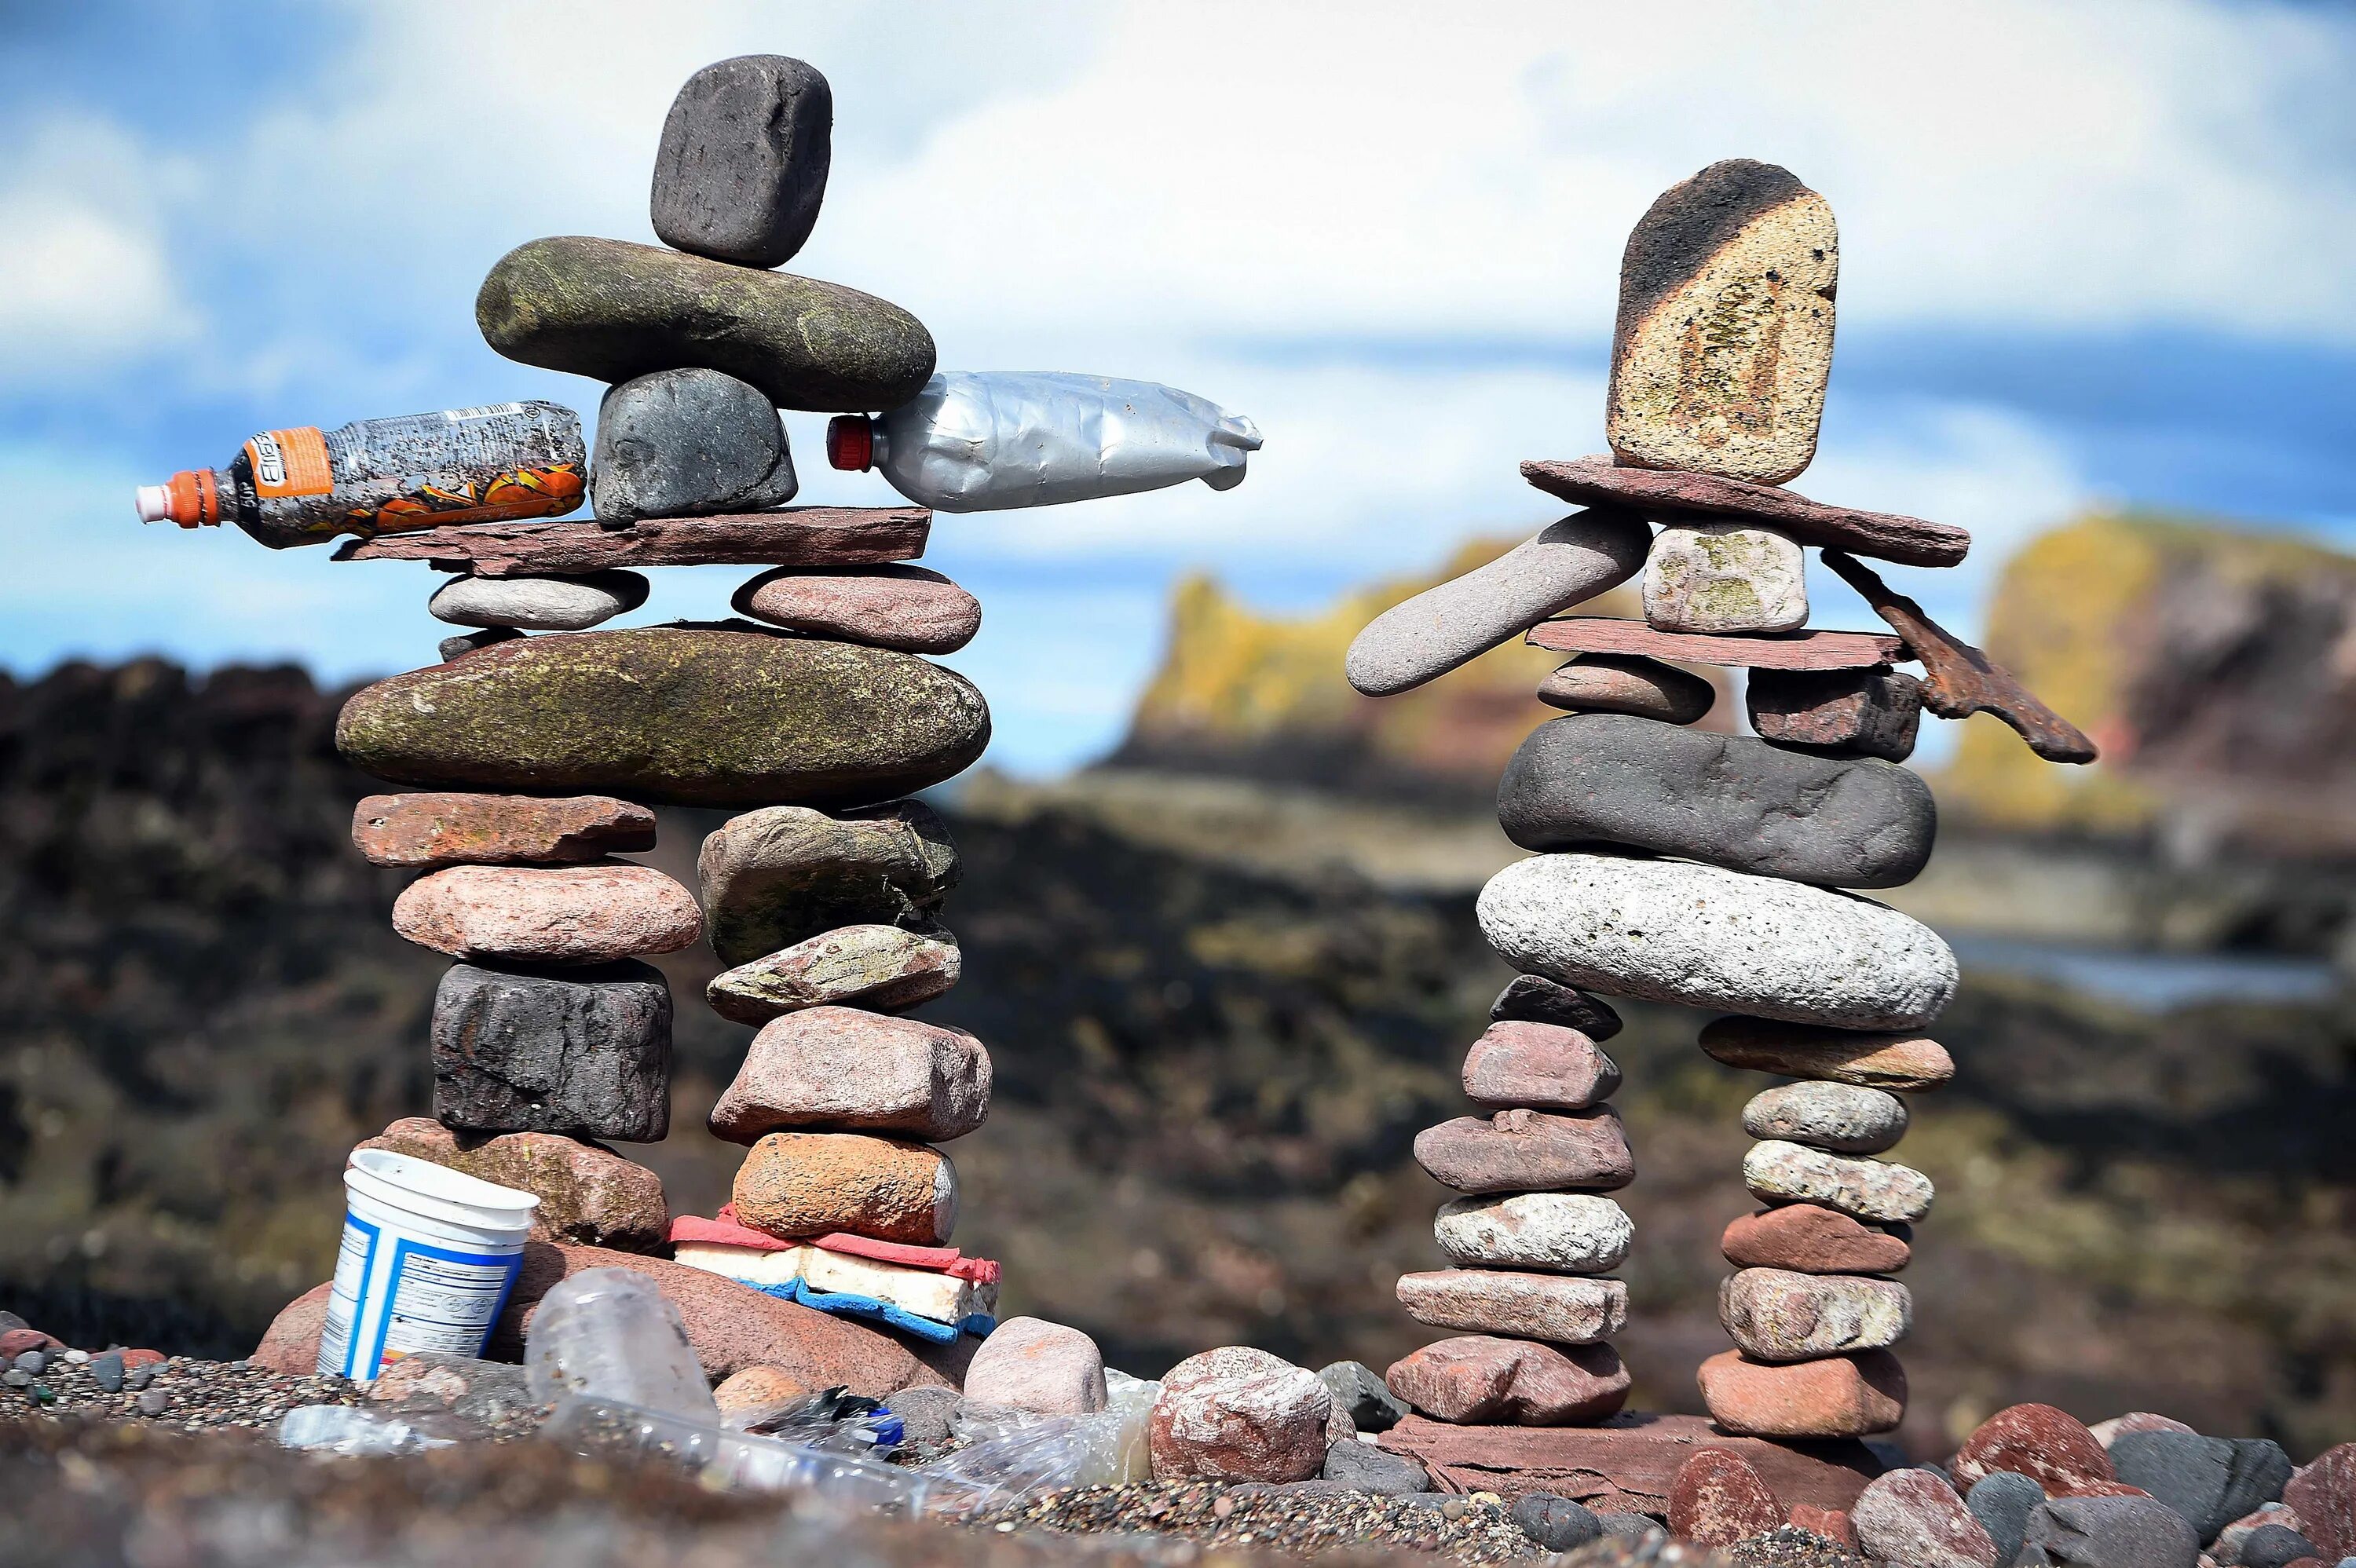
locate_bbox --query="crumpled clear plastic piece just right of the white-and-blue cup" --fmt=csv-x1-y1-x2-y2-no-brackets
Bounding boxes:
523,1269,721,1429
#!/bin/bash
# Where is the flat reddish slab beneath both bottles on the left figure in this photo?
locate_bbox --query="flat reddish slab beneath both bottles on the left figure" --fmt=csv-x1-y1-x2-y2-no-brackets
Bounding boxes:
335,506,933,577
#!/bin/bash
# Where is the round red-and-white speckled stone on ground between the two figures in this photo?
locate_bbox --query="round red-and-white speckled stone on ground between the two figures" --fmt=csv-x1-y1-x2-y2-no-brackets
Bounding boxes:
1145,1344,1333,1481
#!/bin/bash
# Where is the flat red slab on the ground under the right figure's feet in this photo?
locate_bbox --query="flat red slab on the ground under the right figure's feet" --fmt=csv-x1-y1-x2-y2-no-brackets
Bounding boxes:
1376,1410,1882,1519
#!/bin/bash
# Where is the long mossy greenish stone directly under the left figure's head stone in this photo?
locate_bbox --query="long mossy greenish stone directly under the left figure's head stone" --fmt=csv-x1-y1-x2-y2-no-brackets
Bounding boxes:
474,236,933,415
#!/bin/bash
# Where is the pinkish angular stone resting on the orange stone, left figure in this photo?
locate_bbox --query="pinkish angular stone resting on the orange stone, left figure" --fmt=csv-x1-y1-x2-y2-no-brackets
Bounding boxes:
709,1007,990,1144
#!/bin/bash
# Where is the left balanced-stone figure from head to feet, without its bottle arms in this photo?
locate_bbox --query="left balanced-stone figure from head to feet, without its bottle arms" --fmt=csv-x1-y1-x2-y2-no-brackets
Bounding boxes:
337,57,997,1342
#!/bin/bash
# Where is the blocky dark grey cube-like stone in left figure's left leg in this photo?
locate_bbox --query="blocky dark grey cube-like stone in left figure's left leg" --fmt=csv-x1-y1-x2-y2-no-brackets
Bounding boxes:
434,958,671,1144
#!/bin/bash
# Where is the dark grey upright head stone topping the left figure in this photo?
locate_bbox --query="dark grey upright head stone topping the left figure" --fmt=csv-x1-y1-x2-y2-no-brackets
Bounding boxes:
648,54,834,266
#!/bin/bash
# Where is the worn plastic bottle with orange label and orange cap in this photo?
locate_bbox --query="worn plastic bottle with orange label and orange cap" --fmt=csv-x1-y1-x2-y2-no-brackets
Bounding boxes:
139,403,589,551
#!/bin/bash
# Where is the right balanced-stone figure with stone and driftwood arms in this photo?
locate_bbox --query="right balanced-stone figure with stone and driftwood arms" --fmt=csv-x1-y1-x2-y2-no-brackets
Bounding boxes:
1348,160,2094,1438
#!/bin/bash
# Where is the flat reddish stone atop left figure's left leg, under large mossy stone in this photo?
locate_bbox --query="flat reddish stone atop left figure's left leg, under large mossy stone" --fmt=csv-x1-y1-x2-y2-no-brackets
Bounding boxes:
351,793,655,871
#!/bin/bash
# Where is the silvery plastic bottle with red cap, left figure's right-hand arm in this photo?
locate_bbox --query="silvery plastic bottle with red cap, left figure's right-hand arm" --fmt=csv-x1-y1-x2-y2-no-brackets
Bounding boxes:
827,370,1260,511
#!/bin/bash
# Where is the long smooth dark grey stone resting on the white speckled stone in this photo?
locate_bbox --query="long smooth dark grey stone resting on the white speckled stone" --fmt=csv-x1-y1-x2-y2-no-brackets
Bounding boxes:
1496,714,1939,887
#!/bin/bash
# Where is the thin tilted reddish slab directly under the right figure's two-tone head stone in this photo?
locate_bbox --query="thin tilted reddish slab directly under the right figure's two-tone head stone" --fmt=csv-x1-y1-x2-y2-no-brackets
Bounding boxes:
1522,457,1972,565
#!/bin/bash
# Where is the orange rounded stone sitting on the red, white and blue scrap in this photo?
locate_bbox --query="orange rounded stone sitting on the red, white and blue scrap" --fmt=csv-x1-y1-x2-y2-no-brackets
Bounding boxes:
733,1132,957,1248
